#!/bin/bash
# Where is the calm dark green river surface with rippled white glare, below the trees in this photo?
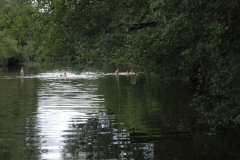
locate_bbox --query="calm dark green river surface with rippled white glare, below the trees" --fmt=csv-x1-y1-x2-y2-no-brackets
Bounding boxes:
0,63,239,160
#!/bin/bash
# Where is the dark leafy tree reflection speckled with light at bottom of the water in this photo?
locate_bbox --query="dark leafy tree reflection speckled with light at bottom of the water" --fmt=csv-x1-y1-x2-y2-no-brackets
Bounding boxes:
63,116,154,159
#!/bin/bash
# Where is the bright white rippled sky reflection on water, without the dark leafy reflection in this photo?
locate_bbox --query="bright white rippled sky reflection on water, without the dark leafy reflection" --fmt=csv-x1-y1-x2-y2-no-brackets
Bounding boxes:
37,73,106,159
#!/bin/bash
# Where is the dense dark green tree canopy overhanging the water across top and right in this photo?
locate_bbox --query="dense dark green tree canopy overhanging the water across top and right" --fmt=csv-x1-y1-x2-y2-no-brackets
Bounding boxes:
0,0,240,134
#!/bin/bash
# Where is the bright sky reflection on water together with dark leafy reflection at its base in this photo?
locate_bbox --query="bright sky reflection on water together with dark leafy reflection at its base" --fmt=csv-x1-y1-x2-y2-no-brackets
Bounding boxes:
36,72,154,159
